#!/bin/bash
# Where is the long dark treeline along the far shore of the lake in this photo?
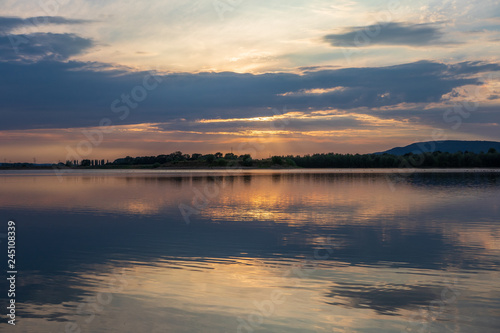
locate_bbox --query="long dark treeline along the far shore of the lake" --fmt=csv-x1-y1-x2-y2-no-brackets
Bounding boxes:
71,148,500,168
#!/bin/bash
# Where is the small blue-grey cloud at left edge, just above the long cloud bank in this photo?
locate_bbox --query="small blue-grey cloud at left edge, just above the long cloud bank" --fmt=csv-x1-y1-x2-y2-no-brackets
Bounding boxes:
0,33,93,62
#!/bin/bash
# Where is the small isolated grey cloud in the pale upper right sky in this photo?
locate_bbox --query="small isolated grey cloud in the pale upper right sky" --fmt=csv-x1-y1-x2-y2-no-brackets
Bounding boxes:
323,22,451,47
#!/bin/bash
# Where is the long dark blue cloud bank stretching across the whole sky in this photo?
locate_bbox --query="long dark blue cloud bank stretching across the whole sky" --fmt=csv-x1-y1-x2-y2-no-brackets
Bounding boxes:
0,59,500,130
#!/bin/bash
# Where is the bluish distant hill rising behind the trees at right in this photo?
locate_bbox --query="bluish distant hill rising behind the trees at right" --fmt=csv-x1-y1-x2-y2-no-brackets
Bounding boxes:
376,140,500,156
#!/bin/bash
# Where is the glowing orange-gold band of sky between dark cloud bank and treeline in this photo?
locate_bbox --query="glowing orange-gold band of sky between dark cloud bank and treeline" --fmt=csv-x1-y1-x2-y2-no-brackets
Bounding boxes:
0,110,446,162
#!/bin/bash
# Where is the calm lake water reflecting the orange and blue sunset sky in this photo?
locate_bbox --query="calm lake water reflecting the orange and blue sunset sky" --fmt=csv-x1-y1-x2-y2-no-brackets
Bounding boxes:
0,170,500,333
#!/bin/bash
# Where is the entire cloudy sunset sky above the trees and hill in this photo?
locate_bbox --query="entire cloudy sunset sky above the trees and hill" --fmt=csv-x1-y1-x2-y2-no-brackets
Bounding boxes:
0,0,500,163
